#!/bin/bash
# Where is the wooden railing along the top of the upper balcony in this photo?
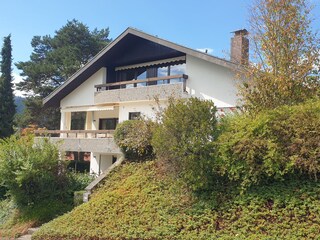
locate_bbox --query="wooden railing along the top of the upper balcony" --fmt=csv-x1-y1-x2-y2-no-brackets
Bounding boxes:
94,74,188,92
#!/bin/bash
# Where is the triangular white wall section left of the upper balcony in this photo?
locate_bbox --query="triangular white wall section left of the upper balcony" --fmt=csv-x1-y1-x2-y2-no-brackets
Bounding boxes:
60,68,107,108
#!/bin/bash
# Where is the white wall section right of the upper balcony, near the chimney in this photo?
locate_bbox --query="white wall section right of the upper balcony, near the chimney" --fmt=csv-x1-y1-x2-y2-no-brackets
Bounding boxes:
186,55,237,107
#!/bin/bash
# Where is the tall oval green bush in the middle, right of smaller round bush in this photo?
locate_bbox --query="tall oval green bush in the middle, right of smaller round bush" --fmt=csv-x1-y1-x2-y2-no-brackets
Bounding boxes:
152,98,217,190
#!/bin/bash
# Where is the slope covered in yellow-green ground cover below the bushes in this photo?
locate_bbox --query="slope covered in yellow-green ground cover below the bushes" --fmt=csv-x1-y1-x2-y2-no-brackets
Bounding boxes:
32,162,320,240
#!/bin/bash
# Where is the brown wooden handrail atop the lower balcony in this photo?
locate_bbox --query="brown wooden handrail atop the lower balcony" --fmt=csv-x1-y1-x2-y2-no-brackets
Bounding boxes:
34,130,114,138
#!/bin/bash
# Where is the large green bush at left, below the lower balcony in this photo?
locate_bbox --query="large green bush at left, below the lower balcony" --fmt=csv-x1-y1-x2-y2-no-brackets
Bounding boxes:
0,136,91,222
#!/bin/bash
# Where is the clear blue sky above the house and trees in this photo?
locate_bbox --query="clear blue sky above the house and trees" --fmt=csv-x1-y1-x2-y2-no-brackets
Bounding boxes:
0,0,320,95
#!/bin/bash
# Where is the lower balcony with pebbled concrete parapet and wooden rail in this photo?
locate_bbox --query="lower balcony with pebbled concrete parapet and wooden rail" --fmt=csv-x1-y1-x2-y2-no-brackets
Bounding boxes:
34,130,121,154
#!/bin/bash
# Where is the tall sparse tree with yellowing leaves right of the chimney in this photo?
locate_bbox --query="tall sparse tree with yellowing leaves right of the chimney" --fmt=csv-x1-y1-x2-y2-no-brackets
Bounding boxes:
240,0,319,111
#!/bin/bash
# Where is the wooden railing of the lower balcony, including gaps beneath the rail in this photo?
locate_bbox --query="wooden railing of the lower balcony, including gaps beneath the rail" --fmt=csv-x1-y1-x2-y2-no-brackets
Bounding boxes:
34,130,114,138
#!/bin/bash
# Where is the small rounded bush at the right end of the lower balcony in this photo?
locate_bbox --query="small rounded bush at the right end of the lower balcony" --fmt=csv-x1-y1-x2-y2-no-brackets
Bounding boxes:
114,120,155,161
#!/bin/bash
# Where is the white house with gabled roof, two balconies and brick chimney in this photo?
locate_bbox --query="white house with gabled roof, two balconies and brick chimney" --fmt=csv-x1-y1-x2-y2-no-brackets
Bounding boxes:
38,28,248,174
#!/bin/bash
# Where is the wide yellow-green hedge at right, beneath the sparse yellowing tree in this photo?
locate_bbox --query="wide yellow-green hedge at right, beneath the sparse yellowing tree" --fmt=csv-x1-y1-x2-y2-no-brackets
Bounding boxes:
218,101,320,188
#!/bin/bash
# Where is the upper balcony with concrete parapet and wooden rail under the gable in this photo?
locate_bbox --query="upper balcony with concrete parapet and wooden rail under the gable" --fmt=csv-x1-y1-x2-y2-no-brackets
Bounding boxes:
94,74,188,104
